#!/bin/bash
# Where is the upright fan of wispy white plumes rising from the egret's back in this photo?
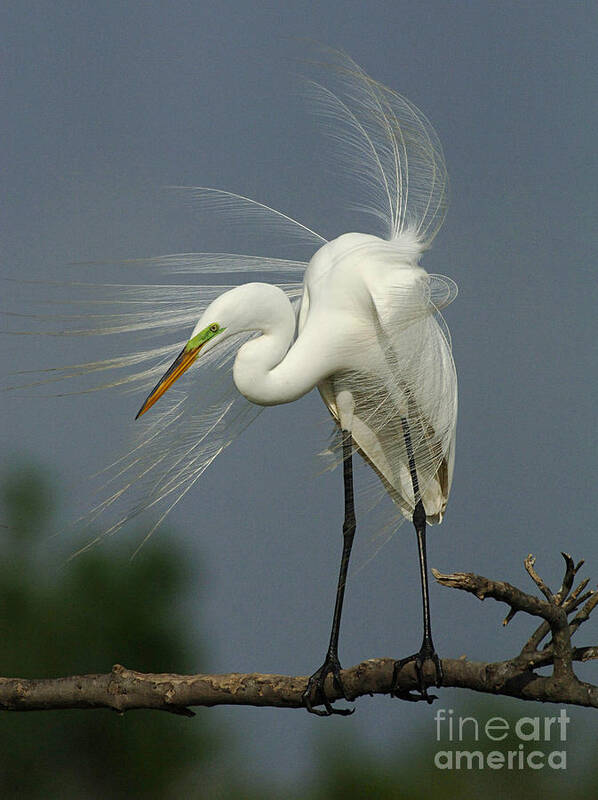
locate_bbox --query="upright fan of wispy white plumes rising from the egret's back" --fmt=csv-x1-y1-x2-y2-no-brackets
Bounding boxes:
311,48,448,247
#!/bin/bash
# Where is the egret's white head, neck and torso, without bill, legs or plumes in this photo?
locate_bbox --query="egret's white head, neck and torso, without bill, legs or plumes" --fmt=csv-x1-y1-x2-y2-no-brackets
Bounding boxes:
196,233,456,522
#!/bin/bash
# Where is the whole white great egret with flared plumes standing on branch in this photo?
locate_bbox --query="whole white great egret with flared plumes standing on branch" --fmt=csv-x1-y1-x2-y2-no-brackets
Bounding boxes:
18,52,457,715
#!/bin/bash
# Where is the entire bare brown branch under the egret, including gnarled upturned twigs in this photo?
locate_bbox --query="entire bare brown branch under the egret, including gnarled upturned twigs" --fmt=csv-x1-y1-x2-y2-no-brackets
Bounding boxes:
0,553,598,716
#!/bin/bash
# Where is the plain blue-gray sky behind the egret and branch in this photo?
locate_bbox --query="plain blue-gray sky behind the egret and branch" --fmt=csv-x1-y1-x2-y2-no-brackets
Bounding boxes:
0,0,598,788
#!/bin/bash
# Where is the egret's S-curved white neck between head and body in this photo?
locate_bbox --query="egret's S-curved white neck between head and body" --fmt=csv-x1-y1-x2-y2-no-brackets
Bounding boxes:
233,287,326,406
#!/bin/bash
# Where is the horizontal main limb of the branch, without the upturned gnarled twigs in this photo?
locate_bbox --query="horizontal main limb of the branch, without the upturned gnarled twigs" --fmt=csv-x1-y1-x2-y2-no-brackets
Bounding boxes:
0,648,598,716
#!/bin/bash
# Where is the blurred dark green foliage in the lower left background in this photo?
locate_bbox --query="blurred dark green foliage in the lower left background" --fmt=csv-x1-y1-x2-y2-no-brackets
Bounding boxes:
0,471,219,798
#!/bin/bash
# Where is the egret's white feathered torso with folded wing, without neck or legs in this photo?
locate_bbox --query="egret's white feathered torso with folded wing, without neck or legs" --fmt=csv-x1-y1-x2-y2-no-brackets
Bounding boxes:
295,228,457,522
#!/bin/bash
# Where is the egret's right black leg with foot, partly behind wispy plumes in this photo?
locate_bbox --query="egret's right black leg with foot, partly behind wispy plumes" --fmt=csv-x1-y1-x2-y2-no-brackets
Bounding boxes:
391,418,443,703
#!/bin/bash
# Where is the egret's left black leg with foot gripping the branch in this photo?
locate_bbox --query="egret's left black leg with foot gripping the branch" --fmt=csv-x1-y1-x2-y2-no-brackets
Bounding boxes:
302,430,356,717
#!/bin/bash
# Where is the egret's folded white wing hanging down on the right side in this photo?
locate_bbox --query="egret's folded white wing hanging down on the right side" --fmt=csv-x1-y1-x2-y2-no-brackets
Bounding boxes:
366,271,457,522
